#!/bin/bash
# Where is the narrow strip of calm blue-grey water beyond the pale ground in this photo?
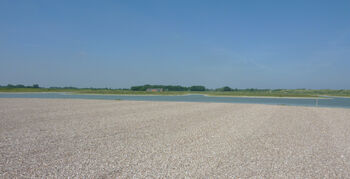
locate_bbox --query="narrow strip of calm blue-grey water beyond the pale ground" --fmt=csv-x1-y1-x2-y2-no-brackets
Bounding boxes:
0,93,350,108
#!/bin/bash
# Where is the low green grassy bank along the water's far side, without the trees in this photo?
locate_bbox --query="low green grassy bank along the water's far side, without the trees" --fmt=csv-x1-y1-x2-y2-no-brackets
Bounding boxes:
0,88,350,97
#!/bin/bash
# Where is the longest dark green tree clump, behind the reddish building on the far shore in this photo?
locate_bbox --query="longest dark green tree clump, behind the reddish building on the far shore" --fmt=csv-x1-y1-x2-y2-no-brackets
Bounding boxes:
130,85,206,91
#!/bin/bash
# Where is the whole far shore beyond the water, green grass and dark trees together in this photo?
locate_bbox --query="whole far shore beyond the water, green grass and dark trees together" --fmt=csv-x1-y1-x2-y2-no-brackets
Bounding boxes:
0,85,350,99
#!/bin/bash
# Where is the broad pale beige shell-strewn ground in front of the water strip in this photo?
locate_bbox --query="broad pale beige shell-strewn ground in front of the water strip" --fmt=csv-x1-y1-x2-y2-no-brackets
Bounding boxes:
0,99,350,178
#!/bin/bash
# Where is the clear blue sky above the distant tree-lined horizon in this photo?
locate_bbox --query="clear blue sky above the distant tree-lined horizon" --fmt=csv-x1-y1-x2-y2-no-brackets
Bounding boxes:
0,0,350,89
